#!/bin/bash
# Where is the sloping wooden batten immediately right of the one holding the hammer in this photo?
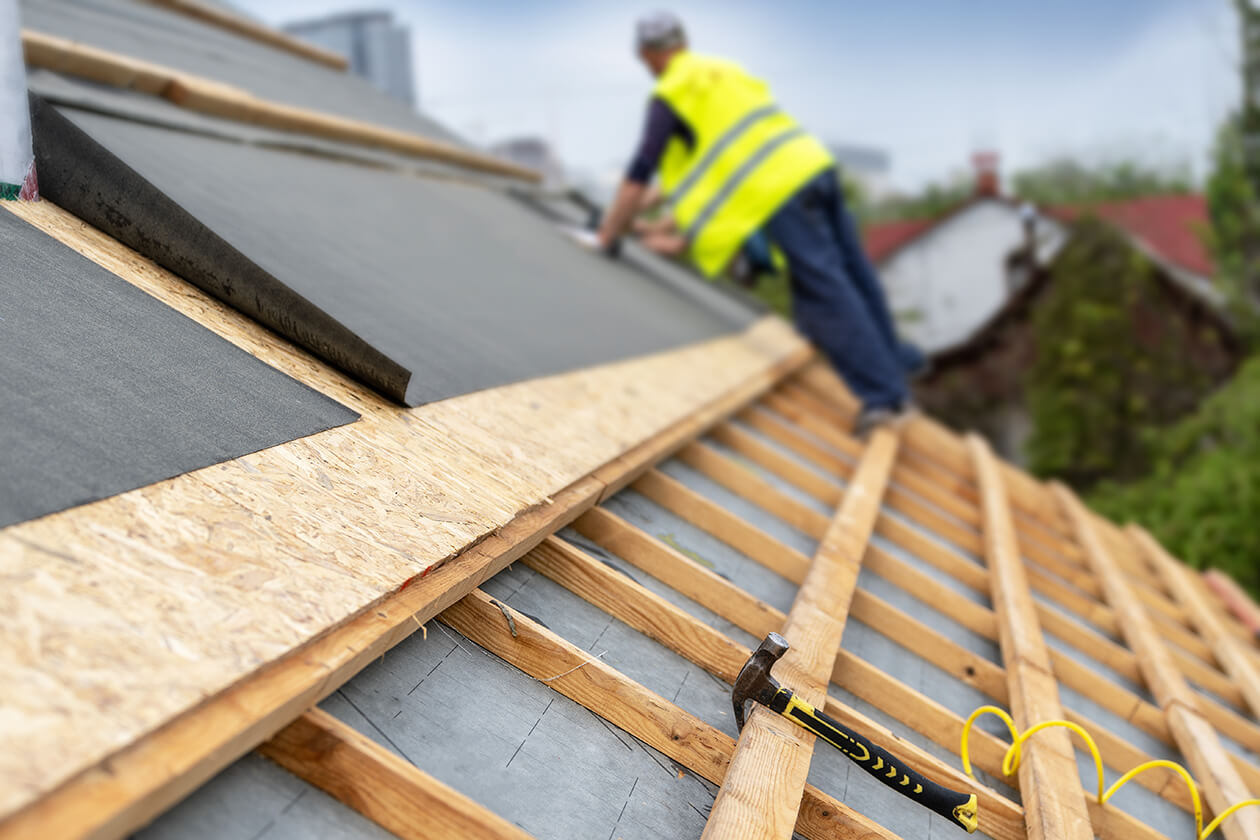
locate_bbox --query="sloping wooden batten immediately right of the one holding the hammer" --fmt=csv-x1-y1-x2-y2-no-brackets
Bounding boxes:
968,434,1094,840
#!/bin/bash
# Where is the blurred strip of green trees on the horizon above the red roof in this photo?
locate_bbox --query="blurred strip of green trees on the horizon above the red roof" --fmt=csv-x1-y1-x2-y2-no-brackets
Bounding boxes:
1014,157,1191,205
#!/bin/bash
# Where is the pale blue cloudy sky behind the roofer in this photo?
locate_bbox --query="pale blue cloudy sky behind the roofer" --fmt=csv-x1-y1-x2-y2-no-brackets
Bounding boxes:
236,0,1240,190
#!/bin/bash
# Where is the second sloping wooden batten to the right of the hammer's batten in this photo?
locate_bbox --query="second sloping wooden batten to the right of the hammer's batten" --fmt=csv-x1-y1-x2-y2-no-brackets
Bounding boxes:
1053,485,1260,840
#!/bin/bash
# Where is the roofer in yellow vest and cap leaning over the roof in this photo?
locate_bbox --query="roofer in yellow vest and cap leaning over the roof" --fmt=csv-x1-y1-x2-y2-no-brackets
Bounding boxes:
599,13,922,434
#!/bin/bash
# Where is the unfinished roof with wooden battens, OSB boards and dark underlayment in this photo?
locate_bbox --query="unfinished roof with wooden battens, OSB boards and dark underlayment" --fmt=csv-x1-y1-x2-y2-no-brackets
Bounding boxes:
0,0,1260,840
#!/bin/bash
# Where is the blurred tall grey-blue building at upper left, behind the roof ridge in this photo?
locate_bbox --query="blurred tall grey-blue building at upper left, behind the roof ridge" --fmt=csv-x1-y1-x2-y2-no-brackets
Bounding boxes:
284,10,416,106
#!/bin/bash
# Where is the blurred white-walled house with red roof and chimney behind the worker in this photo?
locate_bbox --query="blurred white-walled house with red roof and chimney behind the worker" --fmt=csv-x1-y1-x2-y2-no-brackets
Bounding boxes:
864,154,1241,463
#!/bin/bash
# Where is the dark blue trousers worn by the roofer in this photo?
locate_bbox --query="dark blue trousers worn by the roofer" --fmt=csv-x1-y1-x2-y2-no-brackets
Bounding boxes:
765,170,924,408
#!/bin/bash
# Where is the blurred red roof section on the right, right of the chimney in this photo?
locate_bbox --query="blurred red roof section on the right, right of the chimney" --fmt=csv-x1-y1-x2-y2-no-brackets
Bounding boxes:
1047,195,1215,277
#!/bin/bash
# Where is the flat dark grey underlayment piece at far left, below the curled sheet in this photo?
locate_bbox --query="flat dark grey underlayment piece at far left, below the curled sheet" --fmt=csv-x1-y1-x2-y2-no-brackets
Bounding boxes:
0,206,358,528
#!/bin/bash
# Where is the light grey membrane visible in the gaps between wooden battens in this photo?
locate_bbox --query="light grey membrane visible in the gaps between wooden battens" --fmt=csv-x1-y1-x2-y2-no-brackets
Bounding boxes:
130,420,1193,840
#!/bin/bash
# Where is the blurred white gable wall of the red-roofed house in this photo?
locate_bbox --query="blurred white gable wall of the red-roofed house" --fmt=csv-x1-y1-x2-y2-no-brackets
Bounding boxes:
881,200,1061,353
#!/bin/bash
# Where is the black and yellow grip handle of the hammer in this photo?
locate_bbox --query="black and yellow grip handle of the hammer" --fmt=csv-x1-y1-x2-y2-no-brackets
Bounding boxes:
767,688,979,834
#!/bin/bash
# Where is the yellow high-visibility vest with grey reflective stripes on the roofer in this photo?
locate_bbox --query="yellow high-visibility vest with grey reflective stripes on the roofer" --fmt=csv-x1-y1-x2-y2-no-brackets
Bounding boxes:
655,52,834,277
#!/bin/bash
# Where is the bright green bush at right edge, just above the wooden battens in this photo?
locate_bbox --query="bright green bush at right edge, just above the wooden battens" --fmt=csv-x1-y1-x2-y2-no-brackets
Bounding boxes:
1090,358,1260,592
